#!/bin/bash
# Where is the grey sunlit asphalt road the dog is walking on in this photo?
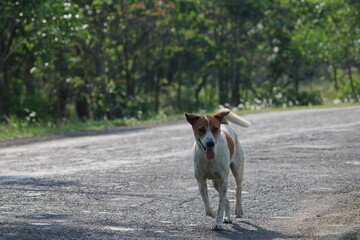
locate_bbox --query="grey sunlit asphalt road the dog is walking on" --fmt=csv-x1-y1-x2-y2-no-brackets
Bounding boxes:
0,106,360,240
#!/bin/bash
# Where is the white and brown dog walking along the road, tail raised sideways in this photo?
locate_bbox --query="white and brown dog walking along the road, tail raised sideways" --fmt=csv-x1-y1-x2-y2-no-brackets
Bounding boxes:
185,110,250,230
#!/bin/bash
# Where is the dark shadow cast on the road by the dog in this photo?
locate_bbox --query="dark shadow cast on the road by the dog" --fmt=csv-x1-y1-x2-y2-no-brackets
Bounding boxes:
217,221,301,240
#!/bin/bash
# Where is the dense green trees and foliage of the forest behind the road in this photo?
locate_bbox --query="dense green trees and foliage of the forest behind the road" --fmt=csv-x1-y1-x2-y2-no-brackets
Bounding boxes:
0,0,360,131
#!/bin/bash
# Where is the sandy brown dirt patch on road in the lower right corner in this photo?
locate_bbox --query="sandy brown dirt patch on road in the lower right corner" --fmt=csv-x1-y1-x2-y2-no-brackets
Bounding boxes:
290,191,360,240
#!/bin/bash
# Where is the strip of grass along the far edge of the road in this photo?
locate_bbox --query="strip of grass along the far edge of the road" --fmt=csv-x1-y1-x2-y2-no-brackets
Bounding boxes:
0,103,359,139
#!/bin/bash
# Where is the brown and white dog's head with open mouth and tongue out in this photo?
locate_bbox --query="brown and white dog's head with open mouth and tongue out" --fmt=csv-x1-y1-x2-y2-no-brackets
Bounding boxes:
185,111,230,160
